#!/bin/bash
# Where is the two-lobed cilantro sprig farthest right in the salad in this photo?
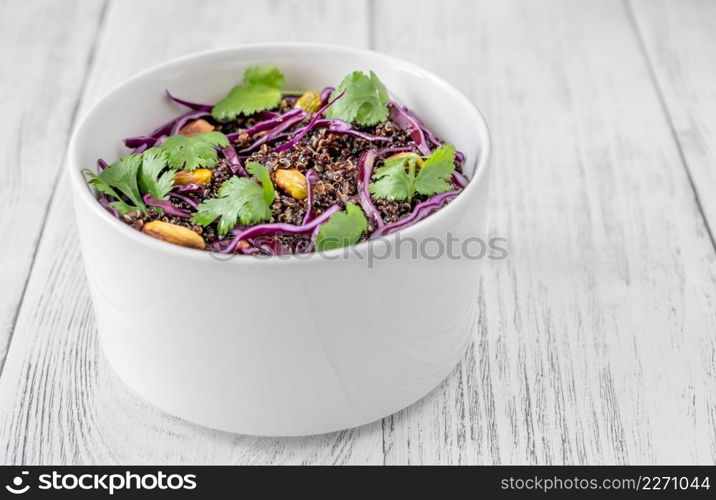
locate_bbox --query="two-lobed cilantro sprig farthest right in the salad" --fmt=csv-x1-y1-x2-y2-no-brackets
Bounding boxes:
369,144,455,201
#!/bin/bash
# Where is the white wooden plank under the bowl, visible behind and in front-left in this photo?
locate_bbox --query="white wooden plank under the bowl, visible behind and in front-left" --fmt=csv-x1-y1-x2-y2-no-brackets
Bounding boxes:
0,0,383,464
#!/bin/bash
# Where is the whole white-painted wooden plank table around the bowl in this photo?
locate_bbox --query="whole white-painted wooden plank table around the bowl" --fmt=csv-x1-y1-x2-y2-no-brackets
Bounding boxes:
0,0,716,464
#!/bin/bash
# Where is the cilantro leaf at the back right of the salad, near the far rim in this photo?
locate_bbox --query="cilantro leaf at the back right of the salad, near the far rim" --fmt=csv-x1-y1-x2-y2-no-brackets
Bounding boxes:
326,71,389,126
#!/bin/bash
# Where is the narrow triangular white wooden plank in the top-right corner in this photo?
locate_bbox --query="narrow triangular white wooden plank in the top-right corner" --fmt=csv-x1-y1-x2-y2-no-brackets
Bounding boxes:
628,0,716,239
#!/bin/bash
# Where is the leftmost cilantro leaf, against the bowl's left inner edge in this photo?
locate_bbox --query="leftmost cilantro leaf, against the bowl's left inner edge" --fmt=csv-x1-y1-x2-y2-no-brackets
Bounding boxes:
86,155,147,215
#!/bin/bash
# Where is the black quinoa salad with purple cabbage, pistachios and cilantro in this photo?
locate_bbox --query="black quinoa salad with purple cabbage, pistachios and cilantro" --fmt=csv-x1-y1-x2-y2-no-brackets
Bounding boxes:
83,66,468,255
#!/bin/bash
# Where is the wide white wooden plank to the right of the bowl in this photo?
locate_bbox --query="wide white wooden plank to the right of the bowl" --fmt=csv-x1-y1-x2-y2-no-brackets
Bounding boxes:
375,0,716,464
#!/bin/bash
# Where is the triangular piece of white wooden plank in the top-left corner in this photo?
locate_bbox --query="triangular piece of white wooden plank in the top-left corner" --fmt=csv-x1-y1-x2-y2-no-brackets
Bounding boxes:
0,0,103,373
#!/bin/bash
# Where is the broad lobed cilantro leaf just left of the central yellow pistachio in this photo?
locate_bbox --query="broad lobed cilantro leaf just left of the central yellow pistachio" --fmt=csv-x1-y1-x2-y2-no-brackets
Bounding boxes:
191,177,271,236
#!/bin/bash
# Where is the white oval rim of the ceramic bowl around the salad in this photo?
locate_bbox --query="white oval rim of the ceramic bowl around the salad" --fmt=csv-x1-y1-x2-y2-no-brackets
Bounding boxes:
66,42,492,265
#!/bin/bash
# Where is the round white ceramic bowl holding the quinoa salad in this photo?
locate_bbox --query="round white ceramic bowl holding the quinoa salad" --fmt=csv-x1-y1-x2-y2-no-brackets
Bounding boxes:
68,43,490,436
